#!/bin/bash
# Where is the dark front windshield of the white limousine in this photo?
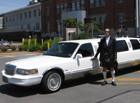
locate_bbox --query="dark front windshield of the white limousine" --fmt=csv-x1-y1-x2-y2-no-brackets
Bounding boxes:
43,43,78,57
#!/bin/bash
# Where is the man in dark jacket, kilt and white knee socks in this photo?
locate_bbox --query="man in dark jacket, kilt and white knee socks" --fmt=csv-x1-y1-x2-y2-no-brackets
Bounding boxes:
92,28,117,86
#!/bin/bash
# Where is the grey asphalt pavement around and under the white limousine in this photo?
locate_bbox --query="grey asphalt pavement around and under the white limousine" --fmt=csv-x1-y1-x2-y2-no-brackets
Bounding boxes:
0,53,140,103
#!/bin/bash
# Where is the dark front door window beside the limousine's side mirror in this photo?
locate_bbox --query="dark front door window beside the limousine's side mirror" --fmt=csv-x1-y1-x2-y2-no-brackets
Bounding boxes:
78,43,94,57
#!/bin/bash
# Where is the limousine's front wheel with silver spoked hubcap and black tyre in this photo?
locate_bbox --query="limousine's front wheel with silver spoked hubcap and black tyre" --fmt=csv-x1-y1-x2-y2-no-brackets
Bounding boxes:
42,71,62,92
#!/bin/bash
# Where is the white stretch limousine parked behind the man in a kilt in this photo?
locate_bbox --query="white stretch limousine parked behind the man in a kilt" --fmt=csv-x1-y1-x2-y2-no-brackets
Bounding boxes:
2,38,140,92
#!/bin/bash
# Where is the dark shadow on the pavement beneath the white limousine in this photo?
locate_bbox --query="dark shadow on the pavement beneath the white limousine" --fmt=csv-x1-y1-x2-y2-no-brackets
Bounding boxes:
0,66,140,97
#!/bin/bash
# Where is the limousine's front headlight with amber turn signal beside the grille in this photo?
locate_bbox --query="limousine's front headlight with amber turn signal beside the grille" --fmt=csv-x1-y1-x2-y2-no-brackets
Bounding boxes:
17,68,38,75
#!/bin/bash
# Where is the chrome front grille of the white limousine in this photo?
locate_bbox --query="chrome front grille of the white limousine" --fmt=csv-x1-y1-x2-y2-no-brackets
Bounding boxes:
5,65,16,76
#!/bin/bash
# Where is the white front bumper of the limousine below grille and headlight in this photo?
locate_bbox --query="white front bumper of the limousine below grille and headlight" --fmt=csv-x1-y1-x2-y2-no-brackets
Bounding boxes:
2,70,43,86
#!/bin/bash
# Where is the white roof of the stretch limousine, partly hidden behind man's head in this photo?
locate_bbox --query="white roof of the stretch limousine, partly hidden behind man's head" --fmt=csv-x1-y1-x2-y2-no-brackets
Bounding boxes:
62,37,140,44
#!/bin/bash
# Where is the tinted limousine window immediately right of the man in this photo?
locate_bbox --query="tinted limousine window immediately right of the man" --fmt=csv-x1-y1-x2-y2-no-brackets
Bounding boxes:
116,40,128,52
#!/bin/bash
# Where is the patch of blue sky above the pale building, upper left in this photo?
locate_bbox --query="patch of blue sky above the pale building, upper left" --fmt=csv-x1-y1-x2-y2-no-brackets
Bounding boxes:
0,0,32,14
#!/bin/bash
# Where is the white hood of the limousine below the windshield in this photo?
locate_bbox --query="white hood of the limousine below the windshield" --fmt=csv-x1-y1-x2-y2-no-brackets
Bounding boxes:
6,55,68,69
